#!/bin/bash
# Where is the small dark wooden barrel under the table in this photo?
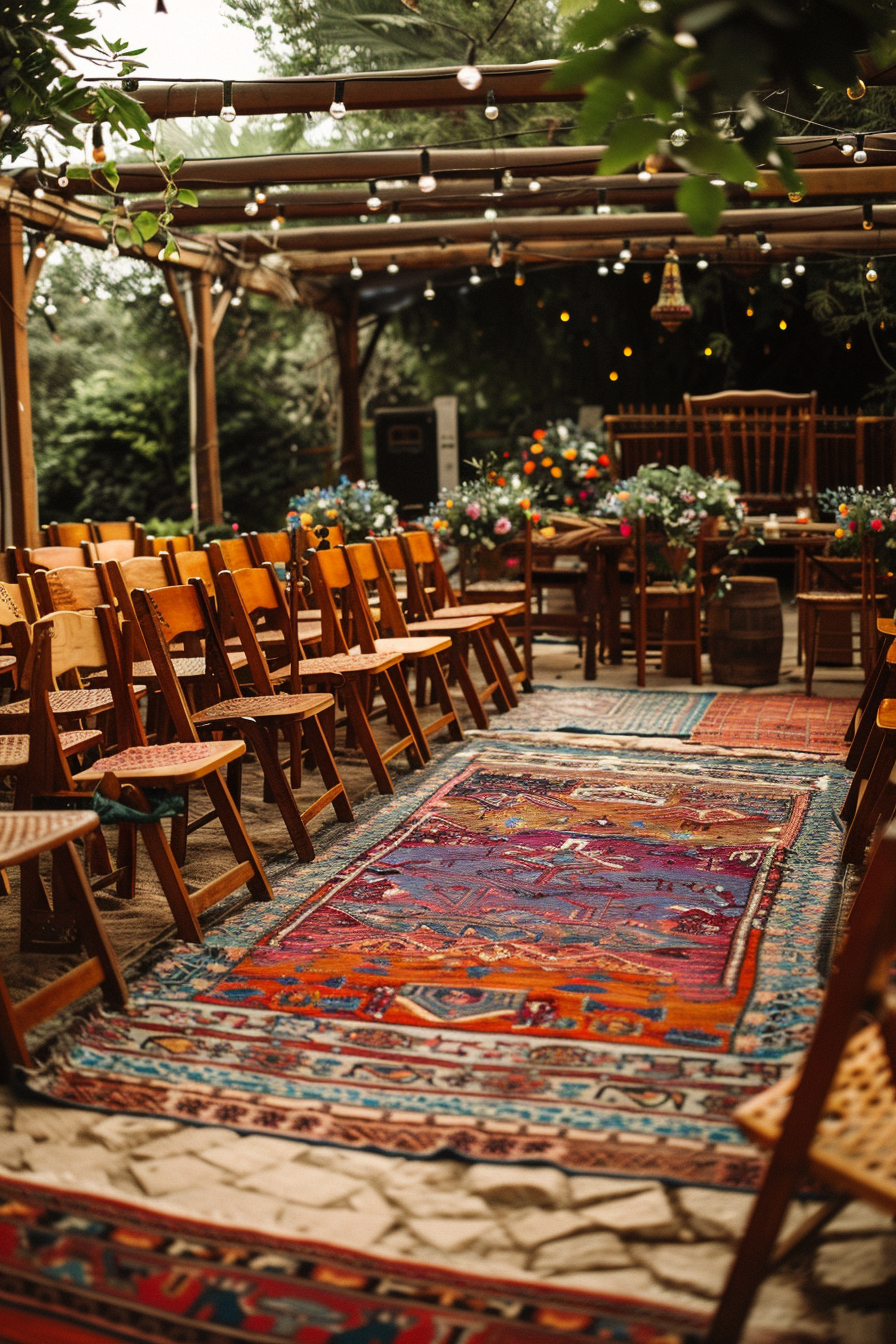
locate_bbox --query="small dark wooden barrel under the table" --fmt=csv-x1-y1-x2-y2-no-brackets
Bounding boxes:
707,577,785,685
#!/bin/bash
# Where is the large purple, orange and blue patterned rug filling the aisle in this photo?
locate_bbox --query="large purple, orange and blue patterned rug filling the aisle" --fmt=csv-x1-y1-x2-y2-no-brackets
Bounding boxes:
30,741,846,1188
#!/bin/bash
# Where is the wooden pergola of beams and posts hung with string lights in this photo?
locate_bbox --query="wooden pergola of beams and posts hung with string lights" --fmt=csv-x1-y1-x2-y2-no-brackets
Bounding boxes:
0,62,896,546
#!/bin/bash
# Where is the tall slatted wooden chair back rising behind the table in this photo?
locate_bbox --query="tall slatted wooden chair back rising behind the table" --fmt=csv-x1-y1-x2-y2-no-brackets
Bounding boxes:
684,391,817,509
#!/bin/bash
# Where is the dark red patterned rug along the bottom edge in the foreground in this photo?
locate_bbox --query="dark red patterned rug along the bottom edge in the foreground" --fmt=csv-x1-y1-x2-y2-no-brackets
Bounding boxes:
0,1177,701,1344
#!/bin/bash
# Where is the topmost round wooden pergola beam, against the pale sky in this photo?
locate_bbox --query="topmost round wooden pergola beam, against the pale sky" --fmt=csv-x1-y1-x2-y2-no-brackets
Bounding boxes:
77,60,583,121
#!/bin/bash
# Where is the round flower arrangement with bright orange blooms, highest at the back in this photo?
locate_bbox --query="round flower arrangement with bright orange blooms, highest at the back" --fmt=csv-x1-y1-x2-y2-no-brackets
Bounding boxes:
513,419,613,513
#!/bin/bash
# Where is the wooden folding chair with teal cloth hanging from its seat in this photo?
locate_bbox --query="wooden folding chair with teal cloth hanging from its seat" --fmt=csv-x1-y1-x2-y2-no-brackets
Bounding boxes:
21,606,271,942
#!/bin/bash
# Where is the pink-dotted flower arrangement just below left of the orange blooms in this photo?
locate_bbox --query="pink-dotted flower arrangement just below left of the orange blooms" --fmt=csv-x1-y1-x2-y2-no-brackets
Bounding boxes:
423,464,540,551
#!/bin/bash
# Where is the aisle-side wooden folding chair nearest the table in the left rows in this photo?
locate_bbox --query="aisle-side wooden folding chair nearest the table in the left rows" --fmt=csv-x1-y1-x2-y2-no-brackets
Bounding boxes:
394,531,527,707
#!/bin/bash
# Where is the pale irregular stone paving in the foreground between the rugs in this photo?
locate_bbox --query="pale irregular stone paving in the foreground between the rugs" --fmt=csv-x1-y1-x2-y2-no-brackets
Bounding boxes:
0,1090,896,1344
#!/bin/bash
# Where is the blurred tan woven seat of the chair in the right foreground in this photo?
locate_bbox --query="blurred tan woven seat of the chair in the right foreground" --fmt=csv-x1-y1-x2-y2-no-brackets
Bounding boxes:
735,1023,896,1214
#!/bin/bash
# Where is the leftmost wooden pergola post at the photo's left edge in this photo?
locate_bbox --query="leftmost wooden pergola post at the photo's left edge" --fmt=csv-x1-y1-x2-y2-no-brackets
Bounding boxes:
0,212,40,546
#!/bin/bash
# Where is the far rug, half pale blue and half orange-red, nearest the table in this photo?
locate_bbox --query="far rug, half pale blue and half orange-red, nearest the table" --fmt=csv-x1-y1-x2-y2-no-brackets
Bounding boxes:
489,685,857,759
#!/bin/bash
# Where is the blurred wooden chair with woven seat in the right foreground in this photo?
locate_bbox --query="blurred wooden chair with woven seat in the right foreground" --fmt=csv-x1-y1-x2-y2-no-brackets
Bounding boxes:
705,827,896,1344
